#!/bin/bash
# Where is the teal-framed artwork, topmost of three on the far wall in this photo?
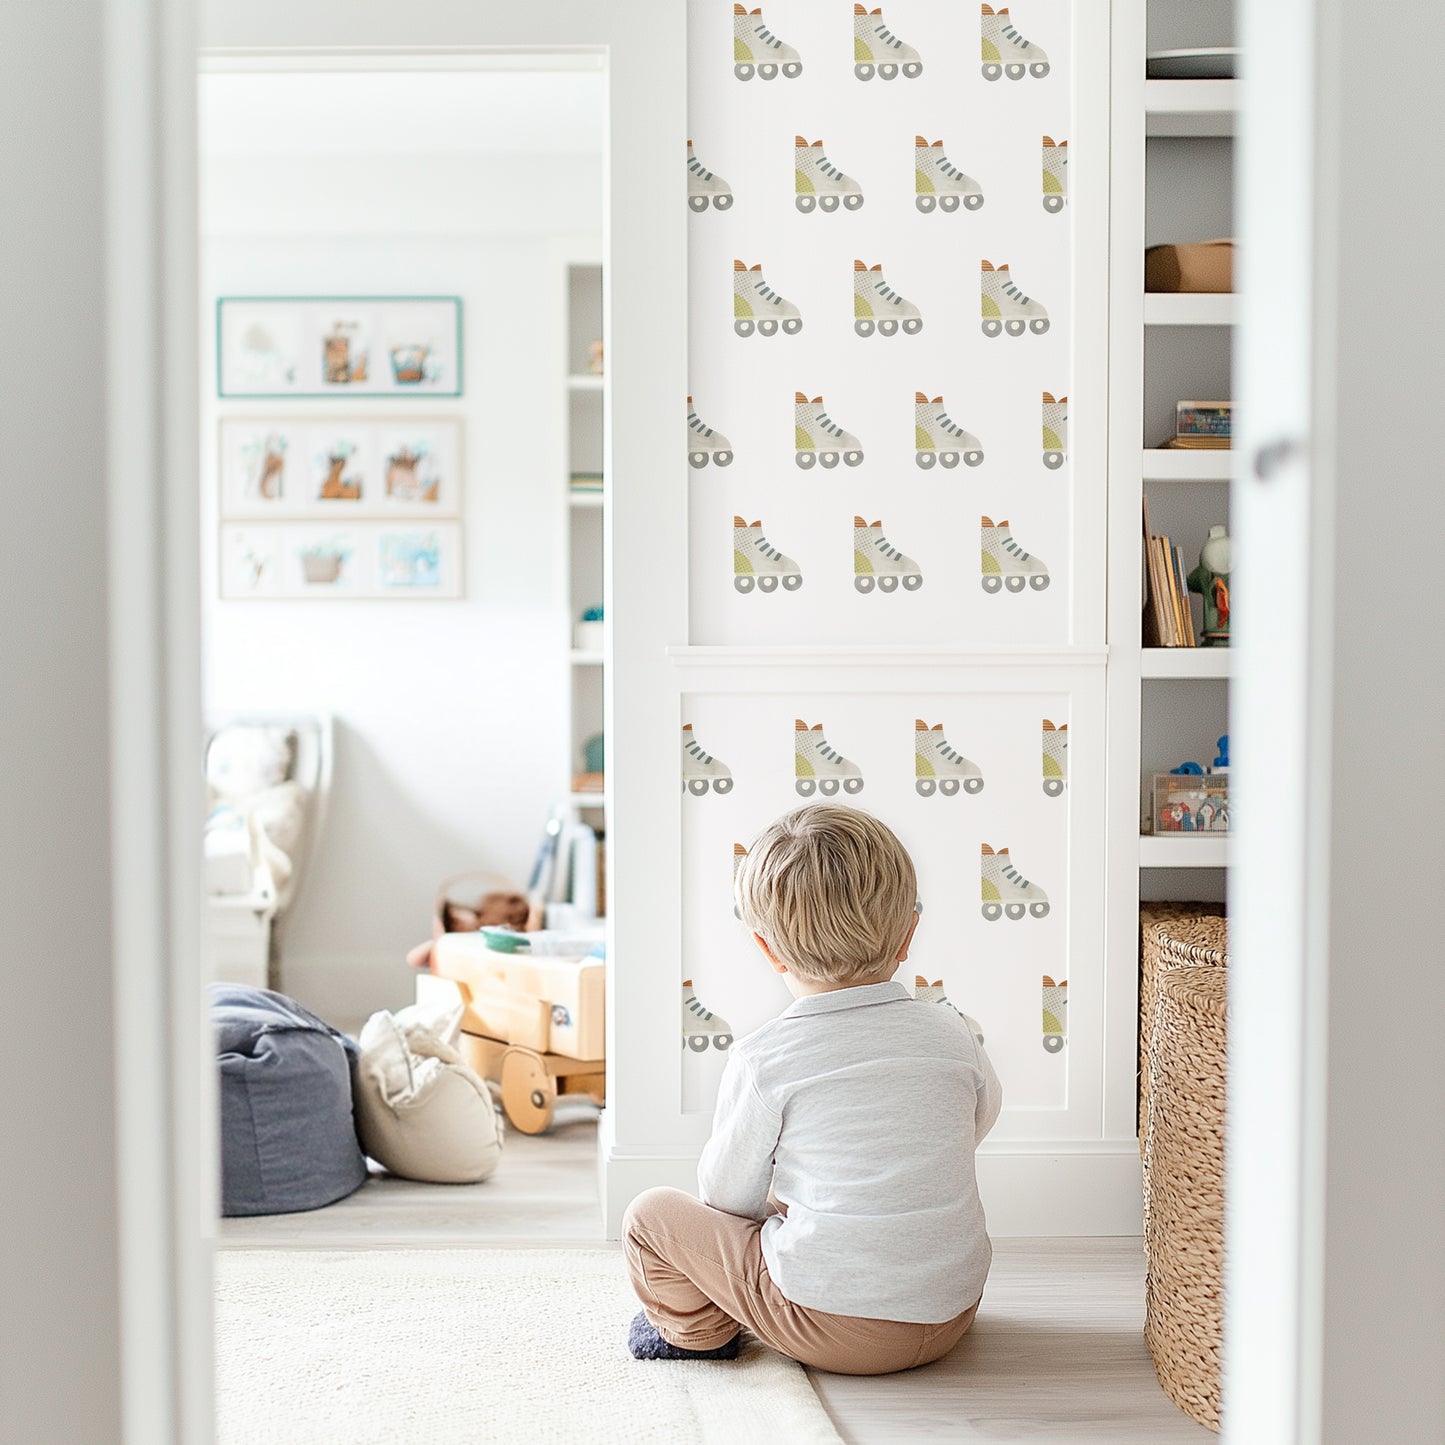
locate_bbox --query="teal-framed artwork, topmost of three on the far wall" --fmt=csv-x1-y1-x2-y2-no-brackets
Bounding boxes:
215,296,461,397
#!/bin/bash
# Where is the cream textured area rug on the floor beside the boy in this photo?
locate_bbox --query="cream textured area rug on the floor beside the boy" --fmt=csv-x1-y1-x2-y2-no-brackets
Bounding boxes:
215,1248,841,1445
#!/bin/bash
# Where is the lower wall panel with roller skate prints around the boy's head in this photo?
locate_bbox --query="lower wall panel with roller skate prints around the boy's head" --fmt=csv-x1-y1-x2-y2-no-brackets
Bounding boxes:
682,691,1072,1111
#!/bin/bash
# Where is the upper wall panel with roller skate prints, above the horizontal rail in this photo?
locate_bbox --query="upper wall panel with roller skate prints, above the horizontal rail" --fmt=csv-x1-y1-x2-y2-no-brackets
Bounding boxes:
678,0,1075,644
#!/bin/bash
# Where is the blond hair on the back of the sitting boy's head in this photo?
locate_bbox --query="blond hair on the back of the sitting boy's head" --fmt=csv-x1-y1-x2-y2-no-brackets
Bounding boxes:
736,803,918,984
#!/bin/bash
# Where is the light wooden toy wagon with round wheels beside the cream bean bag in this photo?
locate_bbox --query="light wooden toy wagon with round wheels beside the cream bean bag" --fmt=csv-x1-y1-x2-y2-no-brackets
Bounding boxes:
416,933,607,1134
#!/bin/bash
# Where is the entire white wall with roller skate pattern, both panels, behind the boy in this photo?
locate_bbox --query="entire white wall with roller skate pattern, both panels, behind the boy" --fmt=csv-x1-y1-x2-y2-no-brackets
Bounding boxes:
679,0,1105,1173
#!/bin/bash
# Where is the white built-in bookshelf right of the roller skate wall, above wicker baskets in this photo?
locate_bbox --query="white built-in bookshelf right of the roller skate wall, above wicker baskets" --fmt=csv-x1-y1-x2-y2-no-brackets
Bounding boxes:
1108,0,1238,919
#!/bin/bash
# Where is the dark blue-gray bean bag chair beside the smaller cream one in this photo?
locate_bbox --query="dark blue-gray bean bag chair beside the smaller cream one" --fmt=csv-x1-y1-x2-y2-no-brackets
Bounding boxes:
211,984,366,1215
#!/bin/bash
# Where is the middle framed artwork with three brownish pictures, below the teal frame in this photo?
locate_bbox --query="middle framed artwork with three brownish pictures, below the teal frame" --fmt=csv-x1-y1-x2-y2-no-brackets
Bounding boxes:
217,416,461,522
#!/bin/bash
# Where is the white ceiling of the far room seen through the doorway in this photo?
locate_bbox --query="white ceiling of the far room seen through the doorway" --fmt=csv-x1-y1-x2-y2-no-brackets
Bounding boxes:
199,69,604,158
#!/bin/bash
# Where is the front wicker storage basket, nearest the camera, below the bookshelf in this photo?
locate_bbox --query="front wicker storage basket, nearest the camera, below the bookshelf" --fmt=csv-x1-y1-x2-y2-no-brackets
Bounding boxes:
1144,968,1227,1431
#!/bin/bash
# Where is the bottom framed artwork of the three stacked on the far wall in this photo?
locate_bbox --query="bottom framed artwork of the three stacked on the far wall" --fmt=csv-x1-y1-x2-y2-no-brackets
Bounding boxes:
220,520,462,601
